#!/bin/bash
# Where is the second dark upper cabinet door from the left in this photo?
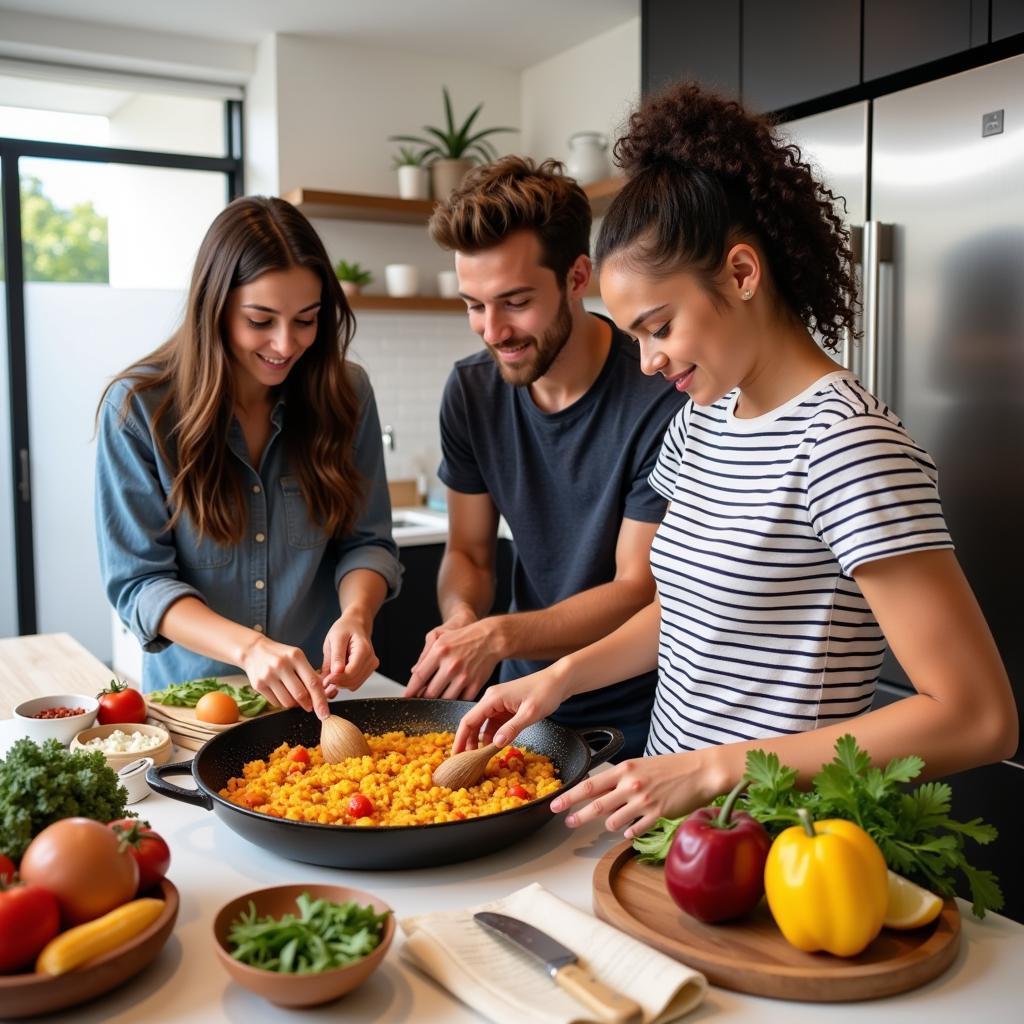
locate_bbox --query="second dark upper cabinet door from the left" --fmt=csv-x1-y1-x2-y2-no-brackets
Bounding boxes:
741,0,860,111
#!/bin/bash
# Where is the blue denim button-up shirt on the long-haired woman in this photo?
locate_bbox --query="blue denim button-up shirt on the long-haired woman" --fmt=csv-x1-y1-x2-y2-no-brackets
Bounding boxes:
95,364,401,690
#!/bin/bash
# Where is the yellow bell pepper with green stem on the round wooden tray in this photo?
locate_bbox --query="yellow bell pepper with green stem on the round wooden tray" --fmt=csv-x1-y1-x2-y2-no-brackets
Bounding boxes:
765,808,889,956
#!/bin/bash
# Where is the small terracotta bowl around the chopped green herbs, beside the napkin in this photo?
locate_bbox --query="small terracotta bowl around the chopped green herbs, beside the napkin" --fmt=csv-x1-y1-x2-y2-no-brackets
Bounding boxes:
213,886,395,1007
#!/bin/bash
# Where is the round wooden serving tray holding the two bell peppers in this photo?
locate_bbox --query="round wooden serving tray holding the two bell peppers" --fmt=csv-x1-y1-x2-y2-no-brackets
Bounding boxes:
594,842,961,1002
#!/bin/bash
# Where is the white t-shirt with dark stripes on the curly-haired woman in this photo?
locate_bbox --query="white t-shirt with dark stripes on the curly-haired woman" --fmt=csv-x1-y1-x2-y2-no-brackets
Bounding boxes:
646,371,952,755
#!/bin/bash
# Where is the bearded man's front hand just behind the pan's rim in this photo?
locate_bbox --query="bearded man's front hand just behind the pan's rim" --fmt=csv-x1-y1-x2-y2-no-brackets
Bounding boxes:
403,606,502,700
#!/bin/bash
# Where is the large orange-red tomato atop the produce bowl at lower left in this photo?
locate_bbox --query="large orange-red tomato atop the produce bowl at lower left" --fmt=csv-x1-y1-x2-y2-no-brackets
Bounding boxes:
18,818,138,925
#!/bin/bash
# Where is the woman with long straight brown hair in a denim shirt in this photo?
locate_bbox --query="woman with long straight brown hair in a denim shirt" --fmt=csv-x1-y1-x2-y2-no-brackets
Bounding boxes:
96,197,401,718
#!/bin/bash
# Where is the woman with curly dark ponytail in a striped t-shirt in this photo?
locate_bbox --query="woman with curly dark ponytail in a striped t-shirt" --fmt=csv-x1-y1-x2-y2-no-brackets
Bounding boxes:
456,77,1017,837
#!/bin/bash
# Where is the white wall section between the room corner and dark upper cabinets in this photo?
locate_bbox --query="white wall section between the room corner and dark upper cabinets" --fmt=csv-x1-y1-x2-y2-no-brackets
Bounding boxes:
520,17,640,167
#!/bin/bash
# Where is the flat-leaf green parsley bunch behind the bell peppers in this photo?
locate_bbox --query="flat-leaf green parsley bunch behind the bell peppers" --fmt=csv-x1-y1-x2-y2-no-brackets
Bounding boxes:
633,734,1002,918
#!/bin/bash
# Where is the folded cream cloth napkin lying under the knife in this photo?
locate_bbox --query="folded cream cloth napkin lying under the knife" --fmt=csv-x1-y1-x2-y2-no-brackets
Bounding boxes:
399,882,708,1024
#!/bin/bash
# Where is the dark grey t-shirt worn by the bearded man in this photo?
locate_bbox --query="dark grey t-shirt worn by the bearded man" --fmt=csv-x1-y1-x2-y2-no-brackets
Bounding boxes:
438,317,685,756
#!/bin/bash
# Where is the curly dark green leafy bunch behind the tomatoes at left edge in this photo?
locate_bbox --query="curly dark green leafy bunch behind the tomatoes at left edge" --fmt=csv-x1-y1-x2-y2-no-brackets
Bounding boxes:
0,739,131,862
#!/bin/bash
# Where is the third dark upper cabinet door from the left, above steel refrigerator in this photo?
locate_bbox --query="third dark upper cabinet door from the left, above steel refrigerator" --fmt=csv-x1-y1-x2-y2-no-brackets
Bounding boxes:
864,0,974,82
